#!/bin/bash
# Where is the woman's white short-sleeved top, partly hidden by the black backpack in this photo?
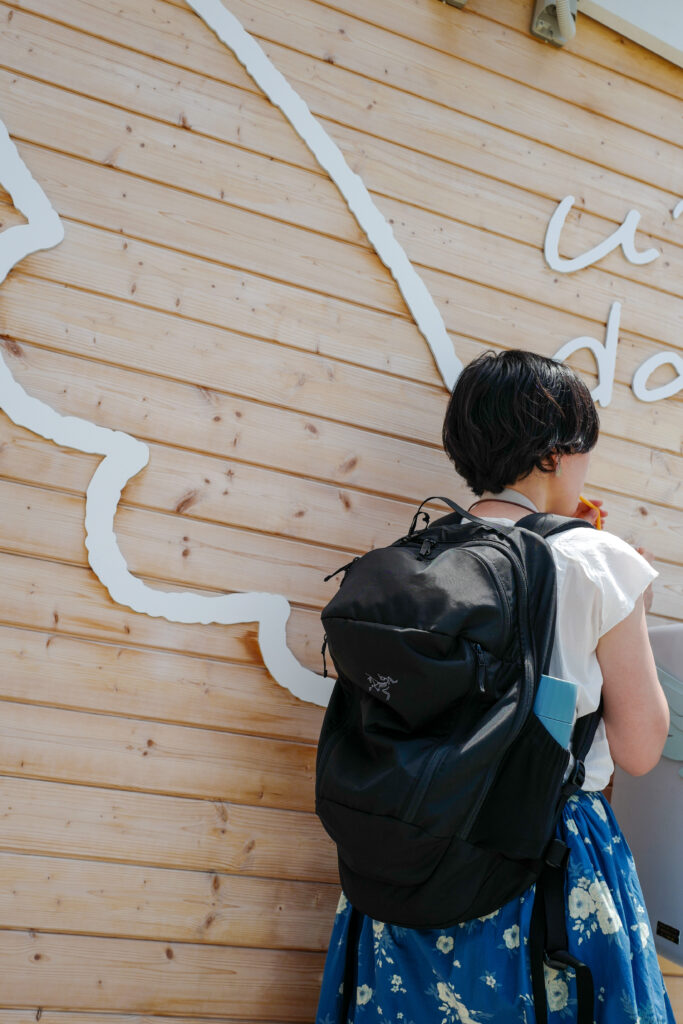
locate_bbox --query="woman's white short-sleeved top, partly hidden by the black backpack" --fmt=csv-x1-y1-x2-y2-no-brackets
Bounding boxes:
479,516,659,791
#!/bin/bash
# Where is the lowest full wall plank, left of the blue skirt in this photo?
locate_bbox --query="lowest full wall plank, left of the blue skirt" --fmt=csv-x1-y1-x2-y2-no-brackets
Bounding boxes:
0,931,324,1022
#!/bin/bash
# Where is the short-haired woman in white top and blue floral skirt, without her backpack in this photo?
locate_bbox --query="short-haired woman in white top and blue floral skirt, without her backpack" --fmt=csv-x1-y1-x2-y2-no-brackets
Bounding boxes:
316,349,675,1024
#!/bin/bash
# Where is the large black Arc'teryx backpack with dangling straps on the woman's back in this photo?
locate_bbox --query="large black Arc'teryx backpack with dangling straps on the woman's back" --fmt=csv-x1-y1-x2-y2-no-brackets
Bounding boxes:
315,498,602,1024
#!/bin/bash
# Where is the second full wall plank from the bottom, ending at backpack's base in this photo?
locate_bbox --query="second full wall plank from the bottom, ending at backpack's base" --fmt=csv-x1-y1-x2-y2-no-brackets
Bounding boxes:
0,853,339,951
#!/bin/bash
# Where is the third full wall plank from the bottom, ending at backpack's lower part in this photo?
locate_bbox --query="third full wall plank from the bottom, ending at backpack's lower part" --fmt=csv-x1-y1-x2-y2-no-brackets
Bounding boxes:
0,776,338,884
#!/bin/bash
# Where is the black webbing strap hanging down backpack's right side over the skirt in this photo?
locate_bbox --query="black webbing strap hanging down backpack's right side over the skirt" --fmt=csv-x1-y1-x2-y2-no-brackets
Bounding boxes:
528,697,602,1024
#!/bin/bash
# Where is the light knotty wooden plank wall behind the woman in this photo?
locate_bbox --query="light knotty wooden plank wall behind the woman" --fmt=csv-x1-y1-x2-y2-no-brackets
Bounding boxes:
0,0,683,1024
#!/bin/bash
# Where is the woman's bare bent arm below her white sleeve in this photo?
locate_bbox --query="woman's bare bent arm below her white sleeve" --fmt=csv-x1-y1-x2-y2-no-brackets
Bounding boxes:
596,594,669,775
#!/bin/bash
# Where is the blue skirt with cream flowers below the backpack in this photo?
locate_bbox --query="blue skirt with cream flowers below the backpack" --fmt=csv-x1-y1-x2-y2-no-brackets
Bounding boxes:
315,791,676,1024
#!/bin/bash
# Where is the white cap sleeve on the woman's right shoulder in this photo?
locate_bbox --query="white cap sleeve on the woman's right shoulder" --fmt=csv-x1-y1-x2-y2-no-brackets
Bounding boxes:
557,529,659,639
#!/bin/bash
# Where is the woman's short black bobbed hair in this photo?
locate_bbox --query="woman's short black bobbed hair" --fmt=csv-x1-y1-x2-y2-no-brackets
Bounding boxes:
441,348,600,495
